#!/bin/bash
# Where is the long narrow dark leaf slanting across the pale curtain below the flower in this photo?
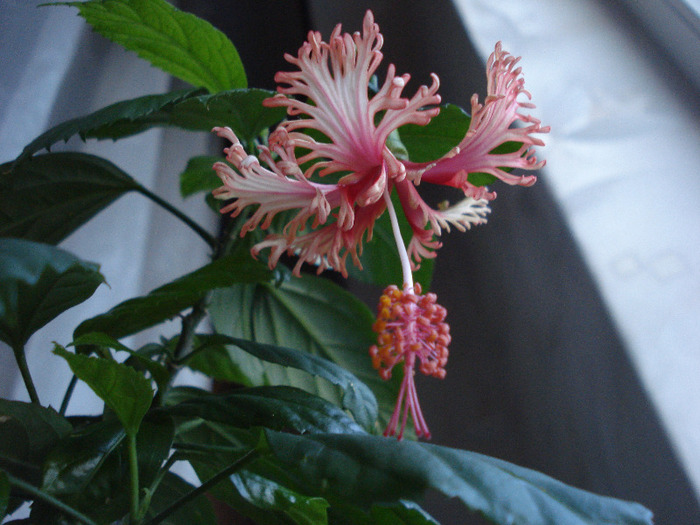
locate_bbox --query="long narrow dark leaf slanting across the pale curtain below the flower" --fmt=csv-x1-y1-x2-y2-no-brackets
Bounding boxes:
74,252,271,339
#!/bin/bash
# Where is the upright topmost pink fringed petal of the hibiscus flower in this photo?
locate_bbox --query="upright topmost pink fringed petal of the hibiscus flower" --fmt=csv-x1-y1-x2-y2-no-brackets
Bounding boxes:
264,11,440,178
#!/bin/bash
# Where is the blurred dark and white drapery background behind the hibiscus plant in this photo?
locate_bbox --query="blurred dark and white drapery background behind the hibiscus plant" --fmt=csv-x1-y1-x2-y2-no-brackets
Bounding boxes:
0,0,700,525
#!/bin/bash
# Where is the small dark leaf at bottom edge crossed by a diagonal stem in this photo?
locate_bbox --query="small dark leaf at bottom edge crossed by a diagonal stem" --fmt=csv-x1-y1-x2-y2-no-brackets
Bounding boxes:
146,472,217,525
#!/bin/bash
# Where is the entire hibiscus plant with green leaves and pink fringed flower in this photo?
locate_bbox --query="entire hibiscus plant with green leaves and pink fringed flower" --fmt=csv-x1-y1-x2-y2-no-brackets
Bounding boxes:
0,0,651,525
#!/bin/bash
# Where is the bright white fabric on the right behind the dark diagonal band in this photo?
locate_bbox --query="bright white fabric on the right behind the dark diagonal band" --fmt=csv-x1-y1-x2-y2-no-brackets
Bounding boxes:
455,0,700,500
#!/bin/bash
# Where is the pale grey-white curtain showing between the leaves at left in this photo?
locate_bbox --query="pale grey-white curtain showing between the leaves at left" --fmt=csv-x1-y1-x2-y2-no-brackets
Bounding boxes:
0,0,217,414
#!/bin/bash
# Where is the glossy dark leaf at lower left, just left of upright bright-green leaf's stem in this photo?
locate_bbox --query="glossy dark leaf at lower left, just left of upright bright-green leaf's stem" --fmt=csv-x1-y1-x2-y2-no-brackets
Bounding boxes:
42,420,126,496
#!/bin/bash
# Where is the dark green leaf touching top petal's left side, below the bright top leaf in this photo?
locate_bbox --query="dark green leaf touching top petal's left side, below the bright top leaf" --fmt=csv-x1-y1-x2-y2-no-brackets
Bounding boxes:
171,88,286,143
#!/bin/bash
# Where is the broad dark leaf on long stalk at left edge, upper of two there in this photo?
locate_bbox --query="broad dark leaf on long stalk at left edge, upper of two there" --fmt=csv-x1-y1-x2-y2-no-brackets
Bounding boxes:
0,153,141,244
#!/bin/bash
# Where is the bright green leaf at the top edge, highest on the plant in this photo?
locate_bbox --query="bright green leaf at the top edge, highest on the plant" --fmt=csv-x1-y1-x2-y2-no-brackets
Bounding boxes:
61,0,247,93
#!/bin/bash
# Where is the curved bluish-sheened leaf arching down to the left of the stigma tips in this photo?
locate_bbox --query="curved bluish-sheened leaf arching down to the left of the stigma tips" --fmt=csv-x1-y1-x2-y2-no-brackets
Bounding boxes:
185,335,377,430
